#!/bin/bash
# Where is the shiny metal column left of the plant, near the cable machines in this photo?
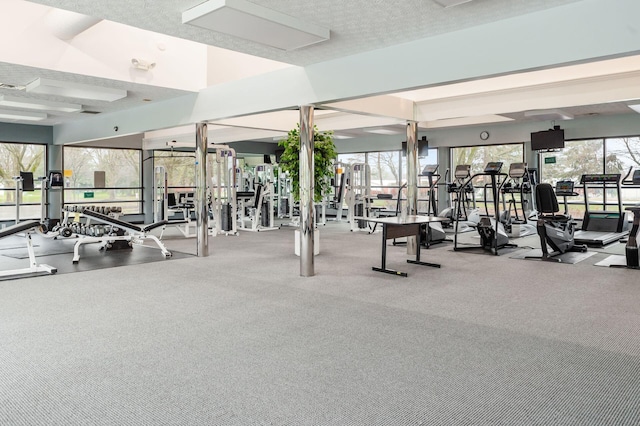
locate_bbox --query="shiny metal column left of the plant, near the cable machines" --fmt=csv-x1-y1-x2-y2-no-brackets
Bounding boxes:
195,123,209,257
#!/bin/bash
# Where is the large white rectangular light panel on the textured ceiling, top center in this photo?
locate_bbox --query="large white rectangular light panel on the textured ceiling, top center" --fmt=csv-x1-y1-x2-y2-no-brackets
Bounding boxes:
182,0,330,50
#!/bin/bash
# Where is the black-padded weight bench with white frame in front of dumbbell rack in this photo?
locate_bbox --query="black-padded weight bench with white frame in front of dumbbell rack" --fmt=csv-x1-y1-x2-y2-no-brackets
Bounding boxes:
73,210,171,263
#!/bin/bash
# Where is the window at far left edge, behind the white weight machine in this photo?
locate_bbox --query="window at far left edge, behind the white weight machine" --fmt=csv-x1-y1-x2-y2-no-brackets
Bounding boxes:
0,143,46,220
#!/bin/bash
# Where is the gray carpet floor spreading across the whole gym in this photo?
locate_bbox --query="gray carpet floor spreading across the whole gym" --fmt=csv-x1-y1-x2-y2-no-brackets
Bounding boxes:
0,223,640,425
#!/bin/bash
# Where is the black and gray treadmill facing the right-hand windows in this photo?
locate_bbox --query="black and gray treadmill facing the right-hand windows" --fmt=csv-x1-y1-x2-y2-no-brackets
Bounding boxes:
575,173,629,247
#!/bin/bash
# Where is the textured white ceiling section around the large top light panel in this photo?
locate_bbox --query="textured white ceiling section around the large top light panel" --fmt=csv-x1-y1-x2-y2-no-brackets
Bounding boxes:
26,0,578,65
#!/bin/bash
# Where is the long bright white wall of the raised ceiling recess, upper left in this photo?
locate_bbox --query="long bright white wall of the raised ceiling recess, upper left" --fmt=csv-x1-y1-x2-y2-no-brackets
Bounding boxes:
0,0,207,91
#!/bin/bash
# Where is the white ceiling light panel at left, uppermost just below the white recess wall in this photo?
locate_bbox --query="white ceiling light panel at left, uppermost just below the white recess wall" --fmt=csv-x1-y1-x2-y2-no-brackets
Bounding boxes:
25,78,127,102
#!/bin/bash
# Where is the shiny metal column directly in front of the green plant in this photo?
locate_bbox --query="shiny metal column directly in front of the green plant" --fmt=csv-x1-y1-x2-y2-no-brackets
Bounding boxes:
300,105,315,277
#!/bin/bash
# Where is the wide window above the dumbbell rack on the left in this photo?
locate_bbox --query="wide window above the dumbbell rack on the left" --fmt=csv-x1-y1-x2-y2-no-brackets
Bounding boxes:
63,146,142,214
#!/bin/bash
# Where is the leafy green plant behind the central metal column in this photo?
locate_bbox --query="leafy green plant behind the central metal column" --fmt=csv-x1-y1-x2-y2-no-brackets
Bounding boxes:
278,124,338,202
